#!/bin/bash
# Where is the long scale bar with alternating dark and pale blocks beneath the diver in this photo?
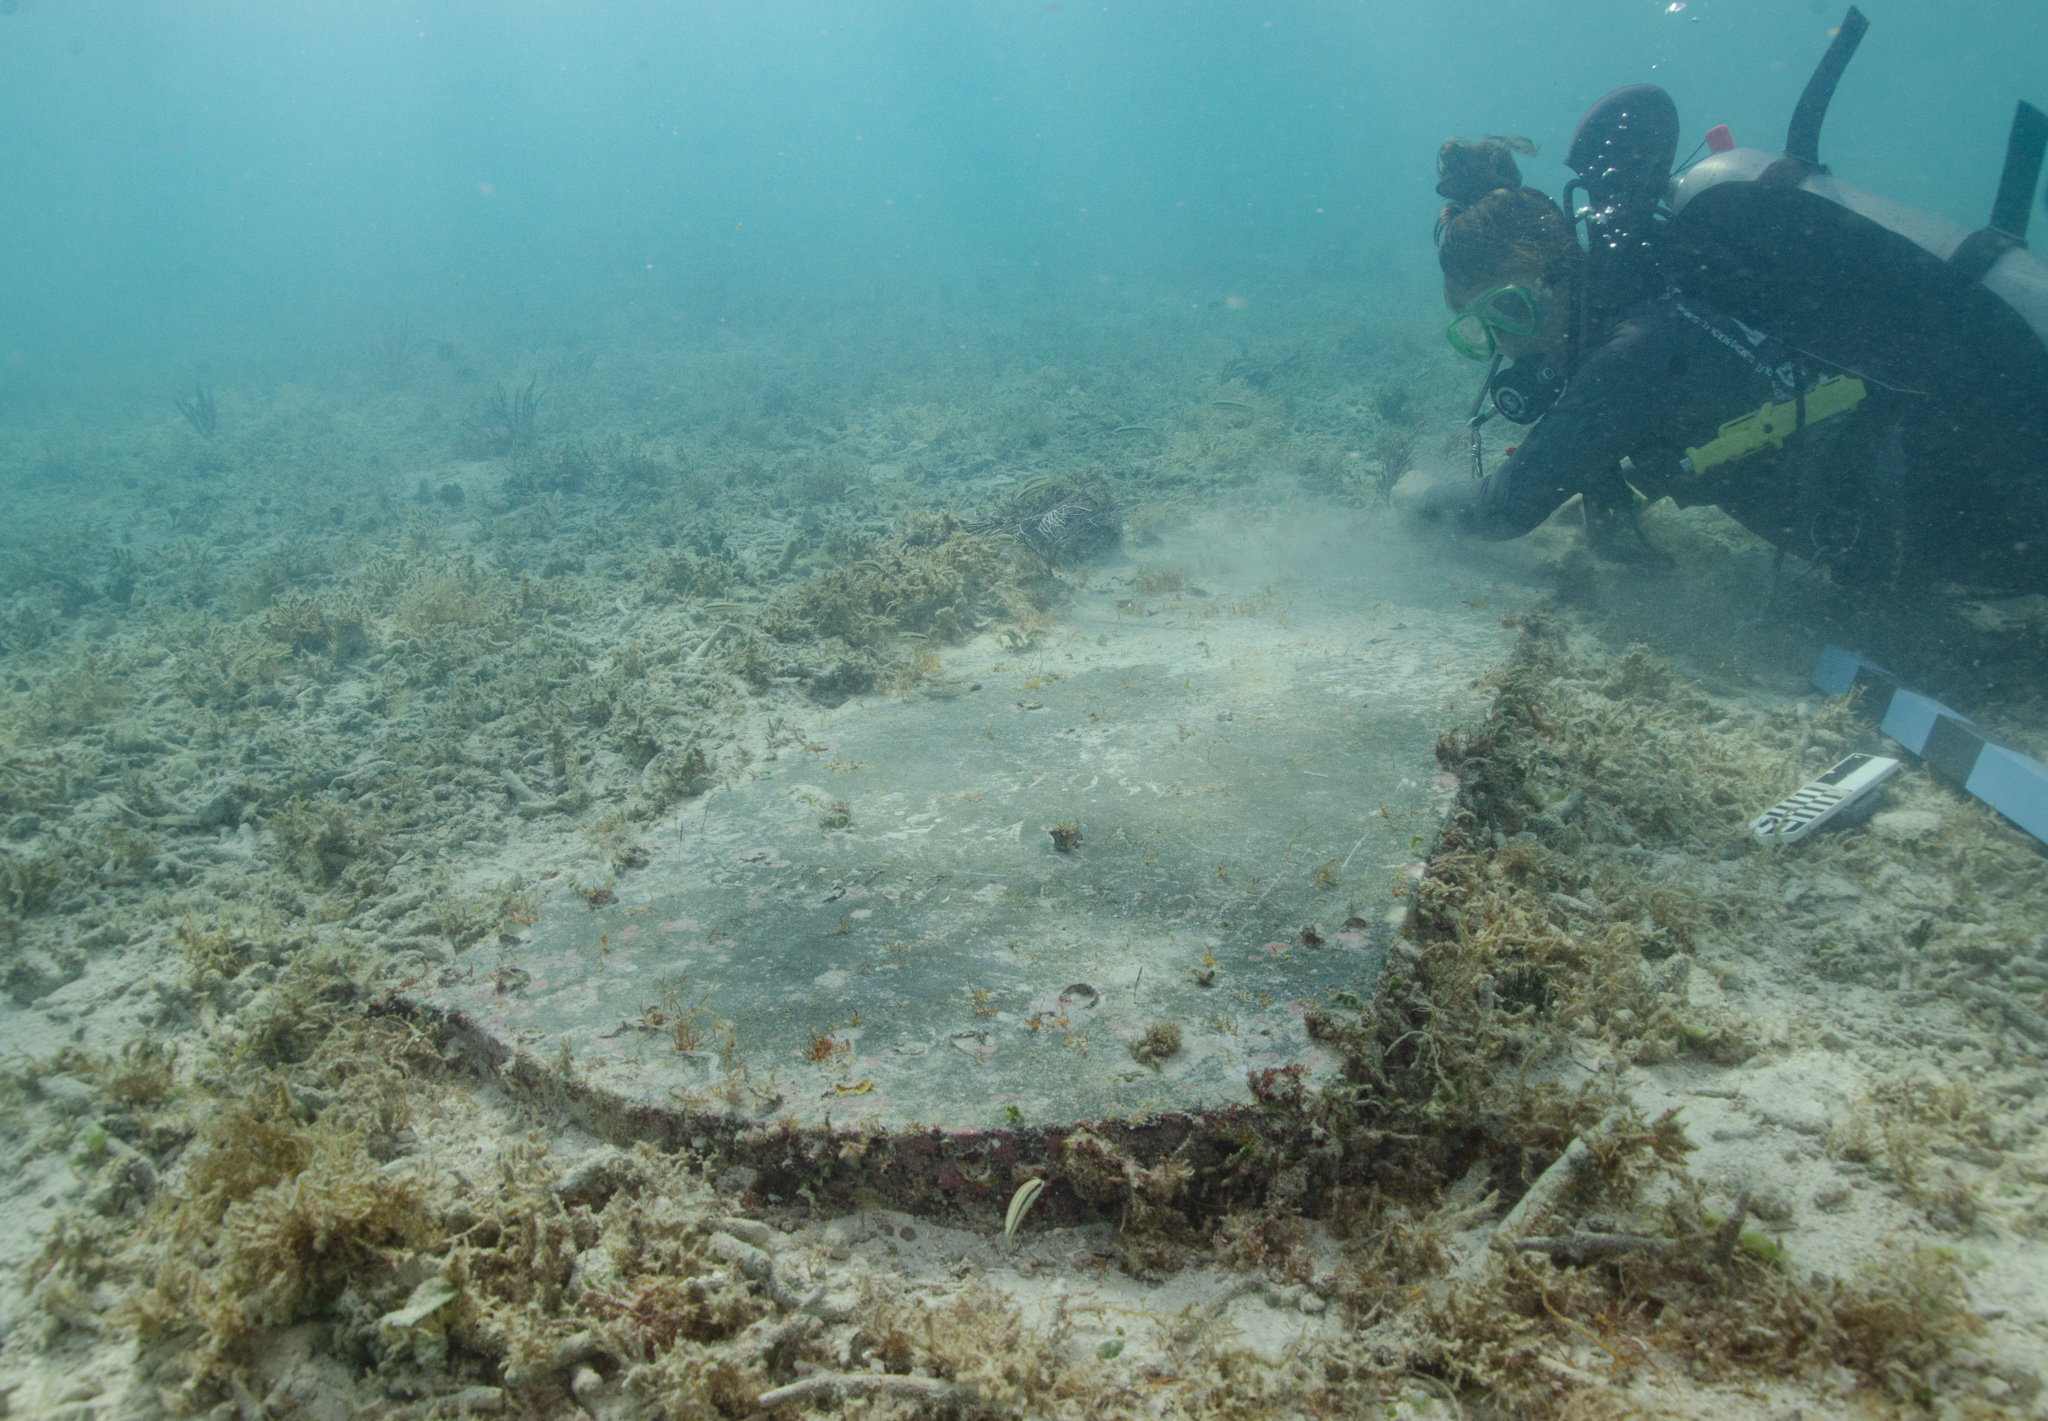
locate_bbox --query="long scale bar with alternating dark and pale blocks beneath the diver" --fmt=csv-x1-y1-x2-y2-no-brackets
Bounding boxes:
1812,647,2048,844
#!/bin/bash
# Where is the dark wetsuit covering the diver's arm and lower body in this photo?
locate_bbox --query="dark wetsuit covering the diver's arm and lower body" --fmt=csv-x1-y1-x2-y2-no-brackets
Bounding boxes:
1421,289,2048,592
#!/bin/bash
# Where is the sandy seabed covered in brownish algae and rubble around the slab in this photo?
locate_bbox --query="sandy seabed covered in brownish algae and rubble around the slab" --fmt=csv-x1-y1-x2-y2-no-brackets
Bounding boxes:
0,284,2048,1421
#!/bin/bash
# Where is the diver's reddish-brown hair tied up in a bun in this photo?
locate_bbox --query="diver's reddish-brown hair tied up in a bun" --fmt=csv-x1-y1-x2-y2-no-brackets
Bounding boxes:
1436,135,1579,291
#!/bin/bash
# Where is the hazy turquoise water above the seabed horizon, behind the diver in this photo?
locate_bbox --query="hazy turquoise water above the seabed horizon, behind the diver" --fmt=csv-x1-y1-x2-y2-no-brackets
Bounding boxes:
0,0,2048,395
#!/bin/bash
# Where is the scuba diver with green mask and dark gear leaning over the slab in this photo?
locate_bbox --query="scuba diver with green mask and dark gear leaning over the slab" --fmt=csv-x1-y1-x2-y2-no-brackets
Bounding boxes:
1417,8,2048,592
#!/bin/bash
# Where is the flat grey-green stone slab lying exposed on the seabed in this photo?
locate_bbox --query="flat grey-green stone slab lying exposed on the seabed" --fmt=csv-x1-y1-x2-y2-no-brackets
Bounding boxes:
416,518,1509,1130
